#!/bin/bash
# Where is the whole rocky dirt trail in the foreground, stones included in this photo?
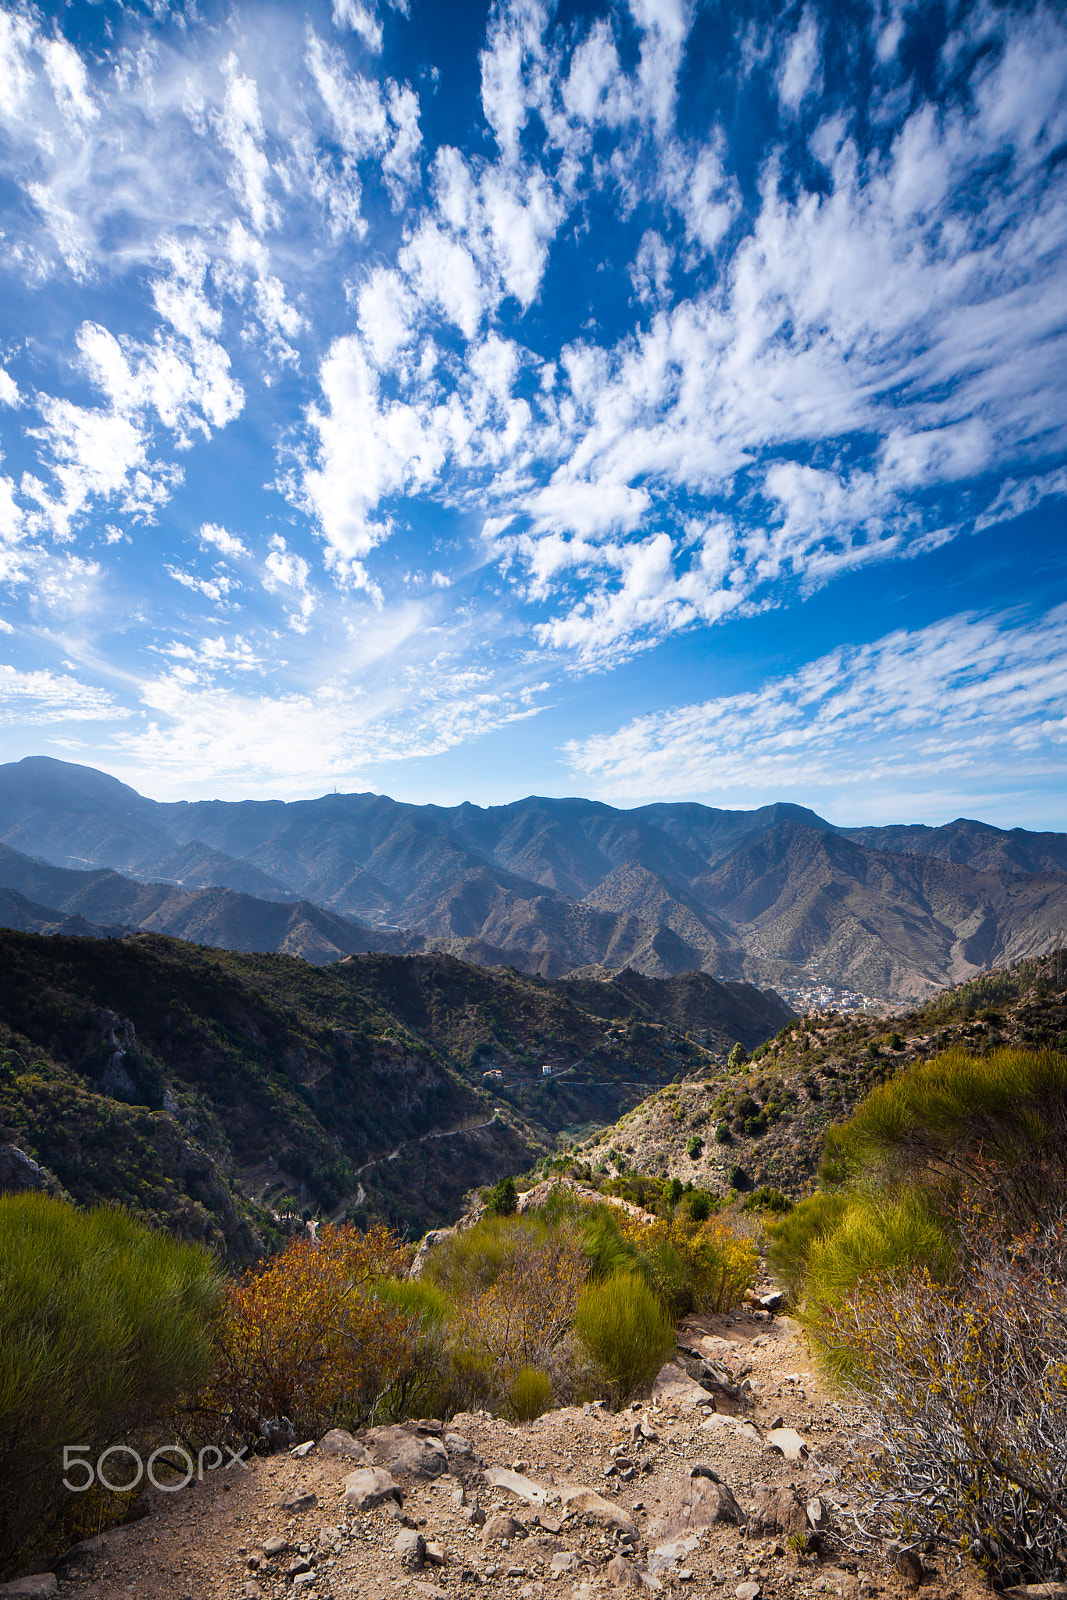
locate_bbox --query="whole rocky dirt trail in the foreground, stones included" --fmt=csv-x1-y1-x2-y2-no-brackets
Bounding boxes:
0,1309,998,1600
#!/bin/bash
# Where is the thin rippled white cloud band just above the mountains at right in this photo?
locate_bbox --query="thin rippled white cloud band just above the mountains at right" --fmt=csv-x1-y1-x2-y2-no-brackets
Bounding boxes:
566,606,1067,797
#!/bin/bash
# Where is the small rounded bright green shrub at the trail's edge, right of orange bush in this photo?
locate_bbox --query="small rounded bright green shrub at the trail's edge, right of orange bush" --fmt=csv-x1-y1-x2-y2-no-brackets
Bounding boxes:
574,1272,675,1406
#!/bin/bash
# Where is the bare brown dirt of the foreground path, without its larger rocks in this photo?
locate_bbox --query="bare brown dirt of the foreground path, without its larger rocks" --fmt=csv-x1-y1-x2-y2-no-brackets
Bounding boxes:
37,1312,991,1600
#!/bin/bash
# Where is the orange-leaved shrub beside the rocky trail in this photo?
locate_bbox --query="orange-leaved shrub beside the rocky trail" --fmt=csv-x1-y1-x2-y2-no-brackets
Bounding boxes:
206,1226,418,1438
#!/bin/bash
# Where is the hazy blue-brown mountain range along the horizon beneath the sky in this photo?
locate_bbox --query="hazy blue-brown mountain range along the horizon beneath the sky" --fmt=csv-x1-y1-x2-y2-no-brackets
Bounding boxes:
0,757,1067,1002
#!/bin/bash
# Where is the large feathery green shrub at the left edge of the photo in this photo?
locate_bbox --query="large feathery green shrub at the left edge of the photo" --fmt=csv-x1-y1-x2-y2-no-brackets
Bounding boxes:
0,1195,219,1571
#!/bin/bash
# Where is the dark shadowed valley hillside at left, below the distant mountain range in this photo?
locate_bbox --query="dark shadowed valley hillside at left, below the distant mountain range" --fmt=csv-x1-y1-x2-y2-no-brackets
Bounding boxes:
0,933,790,1258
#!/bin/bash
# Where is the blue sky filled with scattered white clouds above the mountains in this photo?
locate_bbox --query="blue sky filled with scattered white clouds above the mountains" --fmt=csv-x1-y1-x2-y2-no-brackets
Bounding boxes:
0,0,1067,829
